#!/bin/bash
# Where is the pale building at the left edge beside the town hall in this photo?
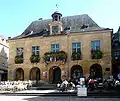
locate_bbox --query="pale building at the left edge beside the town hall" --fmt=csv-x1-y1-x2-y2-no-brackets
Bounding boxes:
0,36,9,81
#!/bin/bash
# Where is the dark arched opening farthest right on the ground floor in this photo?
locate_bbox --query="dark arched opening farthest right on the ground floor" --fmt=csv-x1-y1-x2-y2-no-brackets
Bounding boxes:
89,64,102,79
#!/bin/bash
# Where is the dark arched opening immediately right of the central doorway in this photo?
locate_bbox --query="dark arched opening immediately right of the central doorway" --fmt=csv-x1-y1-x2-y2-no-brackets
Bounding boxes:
71,65,83,81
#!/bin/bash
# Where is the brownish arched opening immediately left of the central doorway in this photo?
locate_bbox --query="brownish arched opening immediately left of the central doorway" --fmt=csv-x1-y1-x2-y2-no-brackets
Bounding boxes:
29,67,40,81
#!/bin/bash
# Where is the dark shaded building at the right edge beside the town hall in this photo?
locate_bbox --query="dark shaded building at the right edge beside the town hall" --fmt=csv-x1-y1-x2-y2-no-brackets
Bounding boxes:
112,27,120,77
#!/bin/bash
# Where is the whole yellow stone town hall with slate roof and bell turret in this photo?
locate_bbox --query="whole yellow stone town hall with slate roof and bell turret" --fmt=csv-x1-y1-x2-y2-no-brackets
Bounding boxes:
8,12,112,83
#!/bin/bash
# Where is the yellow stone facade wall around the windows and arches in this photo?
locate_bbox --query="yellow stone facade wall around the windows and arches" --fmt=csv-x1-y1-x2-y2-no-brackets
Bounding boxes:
8,30,112,81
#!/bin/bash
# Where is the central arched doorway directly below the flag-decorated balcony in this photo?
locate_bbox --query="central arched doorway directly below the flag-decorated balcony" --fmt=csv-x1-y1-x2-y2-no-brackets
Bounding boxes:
49,66,61,83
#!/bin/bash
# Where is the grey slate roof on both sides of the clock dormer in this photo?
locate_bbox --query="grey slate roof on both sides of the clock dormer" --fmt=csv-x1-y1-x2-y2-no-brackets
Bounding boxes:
11,14,109,39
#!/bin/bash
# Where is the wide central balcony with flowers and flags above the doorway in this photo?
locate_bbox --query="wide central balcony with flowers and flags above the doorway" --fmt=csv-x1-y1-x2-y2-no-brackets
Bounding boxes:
43,51,67,64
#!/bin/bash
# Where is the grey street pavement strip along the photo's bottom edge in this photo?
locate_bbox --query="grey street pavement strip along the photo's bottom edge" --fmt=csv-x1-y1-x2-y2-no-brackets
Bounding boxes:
0,96,120,101
